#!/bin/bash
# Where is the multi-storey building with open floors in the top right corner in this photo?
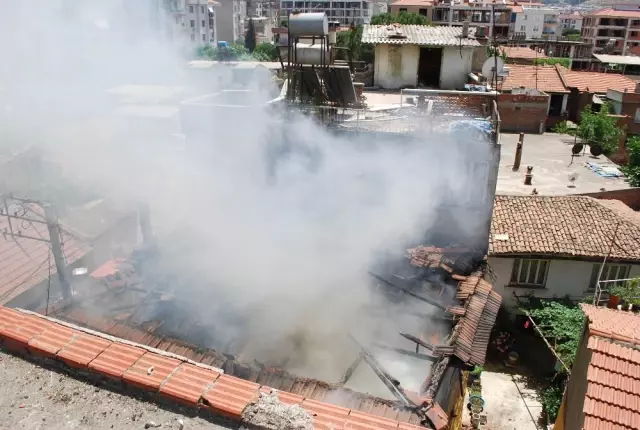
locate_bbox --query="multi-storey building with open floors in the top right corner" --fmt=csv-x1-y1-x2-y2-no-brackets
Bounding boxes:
580,5,640,55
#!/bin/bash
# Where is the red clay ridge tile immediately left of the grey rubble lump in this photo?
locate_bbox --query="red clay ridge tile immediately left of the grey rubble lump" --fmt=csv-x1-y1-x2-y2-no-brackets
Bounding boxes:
202,375,260,420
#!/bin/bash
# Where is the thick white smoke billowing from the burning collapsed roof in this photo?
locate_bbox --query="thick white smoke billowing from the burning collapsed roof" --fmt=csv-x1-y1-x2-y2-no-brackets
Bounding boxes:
0,0,490,390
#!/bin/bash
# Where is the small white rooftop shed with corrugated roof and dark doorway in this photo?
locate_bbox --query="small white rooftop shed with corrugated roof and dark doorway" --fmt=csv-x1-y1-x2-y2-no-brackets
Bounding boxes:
362,24,481,90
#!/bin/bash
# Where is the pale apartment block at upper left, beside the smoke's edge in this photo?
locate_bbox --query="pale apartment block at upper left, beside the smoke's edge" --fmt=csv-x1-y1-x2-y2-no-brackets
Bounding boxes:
163,0,217,45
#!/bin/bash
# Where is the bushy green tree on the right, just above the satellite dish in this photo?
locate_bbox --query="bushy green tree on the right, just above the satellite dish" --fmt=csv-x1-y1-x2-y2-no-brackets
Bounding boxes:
577,103,622,155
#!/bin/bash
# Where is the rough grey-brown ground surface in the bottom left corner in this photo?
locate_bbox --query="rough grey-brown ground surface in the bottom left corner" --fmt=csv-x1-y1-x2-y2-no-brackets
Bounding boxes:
0,351,234,430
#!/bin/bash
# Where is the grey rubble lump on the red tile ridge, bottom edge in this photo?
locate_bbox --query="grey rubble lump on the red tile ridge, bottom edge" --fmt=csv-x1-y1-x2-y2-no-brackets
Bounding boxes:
242,391,313,430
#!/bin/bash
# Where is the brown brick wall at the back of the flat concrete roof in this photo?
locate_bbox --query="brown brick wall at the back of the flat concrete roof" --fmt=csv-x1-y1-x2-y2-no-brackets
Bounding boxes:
498,94,549,133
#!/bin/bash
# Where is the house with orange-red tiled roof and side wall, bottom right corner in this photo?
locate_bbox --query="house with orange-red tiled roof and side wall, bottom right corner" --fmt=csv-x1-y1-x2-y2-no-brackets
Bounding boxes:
555,304,640,430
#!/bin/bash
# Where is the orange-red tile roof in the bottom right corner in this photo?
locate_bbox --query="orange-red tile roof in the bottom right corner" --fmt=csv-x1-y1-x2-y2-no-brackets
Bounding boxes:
581,304,640,430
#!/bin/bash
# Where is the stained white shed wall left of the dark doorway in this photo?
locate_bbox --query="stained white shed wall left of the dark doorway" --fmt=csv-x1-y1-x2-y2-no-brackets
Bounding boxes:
373,45,420,89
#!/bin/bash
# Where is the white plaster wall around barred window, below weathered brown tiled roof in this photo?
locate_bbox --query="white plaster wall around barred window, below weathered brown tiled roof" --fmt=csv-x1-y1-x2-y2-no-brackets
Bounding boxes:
488,257,640,310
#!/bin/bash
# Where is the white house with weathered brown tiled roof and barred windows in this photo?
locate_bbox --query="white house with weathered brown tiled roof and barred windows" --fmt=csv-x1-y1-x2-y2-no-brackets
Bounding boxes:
488,196,640,311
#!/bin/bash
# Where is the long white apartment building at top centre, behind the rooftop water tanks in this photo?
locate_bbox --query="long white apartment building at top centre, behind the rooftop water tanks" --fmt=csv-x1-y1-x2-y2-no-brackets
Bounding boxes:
280,0,372,26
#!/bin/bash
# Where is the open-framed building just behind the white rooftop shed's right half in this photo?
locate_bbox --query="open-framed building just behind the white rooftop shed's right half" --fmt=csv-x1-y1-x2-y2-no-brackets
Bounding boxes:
431,1,520,38
